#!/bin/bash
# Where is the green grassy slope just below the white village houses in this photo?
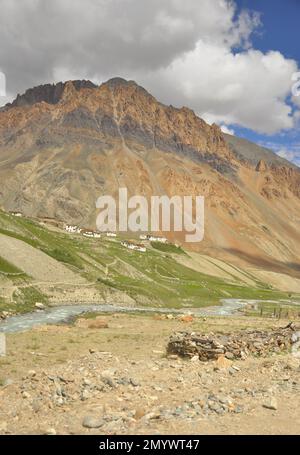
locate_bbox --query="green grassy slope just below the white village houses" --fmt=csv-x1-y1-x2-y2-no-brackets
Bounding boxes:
0,212,298,314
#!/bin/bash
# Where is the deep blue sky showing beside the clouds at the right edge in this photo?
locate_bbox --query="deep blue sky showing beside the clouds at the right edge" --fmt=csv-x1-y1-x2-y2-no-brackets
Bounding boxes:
234,0,300,166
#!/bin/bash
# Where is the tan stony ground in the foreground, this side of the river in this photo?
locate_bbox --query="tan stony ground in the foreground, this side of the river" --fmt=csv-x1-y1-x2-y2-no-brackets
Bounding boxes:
0,314,300,435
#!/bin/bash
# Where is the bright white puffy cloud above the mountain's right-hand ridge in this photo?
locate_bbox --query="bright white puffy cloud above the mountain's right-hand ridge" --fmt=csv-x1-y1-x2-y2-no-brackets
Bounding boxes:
142,42,297,134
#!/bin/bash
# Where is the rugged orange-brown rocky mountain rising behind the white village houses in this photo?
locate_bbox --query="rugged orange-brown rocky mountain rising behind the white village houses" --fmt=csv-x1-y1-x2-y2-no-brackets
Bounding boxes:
0,78,300,276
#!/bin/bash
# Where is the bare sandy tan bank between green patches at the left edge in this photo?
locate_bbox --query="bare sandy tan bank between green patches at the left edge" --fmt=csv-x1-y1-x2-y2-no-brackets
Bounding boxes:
0,234,85,283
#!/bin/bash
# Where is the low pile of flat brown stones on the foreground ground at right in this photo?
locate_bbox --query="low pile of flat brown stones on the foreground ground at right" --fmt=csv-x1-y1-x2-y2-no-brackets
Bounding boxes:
167,324,300,361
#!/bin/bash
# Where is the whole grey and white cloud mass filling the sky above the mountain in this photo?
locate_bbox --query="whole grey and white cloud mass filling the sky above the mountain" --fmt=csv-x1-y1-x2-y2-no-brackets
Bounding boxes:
0,0,298,134
